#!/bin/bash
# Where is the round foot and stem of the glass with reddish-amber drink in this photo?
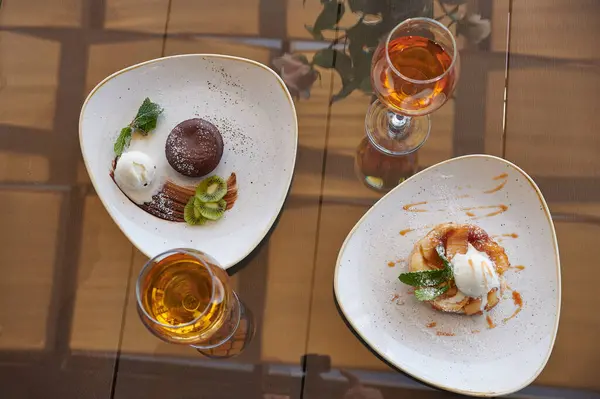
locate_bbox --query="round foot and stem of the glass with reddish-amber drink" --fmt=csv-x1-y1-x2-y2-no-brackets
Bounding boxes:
365,100,431,155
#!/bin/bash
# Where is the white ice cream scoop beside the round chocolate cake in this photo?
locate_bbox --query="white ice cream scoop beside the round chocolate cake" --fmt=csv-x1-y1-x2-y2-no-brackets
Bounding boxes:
115,151,156,190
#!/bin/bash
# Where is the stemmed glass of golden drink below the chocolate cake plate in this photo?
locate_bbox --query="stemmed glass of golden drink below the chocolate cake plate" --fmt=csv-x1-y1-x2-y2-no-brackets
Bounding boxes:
136,249,254,358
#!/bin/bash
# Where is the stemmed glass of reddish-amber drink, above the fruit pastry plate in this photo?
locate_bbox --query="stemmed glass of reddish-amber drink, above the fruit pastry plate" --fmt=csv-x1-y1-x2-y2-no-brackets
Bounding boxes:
365,18,459,155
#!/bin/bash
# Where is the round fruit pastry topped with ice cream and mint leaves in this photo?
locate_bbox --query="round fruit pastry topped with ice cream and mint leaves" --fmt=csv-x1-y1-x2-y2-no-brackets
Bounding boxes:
400,223,510,315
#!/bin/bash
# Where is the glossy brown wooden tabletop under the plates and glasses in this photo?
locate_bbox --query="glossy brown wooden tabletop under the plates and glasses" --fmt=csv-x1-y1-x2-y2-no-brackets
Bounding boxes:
0,0,600,398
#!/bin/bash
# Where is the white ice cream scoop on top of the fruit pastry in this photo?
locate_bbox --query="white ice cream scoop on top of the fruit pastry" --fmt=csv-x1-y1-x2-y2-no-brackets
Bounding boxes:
452,244,500,298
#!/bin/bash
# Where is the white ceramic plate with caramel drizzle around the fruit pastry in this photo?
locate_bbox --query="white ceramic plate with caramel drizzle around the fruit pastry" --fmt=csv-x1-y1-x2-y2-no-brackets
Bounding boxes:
334,155,561,396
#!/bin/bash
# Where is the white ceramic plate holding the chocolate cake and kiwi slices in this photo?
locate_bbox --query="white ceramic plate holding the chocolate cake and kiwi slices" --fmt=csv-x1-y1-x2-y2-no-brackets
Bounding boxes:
79,54,298,268
